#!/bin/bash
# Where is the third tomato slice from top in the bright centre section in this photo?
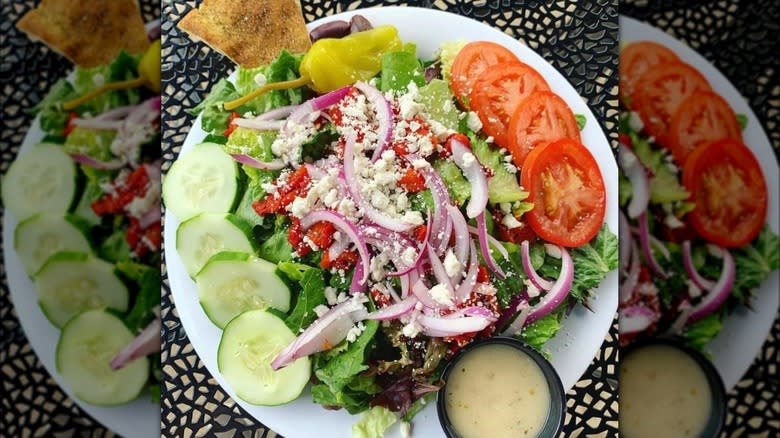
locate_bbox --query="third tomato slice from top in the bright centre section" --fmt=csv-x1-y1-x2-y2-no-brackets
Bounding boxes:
507,91,580,167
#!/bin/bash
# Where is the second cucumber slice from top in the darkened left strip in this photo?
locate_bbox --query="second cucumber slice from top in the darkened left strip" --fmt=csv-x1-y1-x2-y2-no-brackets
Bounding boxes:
14,213,92,276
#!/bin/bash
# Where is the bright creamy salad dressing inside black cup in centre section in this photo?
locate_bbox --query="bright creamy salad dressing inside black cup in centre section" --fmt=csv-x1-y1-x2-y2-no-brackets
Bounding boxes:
444,345,550,438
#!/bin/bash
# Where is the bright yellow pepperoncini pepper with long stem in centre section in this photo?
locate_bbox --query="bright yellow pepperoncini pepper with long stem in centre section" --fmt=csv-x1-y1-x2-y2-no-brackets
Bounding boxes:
224,26,403,111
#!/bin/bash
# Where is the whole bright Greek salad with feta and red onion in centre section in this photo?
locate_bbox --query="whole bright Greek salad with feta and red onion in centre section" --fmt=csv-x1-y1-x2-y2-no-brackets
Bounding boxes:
163,17,618,436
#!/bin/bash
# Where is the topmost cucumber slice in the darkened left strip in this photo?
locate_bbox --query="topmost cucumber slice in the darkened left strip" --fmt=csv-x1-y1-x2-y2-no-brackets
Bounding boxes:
2,143,78,221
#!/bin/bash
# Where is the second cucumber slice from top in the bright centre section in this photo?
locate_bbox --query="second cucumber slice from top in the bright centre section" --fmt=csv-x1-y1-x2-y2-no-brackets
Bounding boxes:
176,213,255,277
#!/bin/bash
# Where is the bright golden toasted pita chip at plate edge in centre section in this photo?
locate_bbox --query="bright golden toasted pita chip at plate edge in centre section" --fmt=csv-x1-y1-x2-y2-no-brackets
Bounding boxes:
179,0,311,67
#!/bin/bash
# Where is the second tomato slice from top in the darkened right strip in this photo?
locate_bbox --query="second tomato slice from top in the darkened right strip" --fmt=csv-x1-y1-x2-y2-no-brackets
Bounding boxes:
631,62,710,146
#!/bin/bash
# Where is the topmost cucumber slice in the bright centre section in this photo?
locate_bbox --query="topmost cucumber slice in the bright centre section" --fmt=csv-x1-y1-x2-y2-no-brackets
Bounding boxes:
163,143,240,221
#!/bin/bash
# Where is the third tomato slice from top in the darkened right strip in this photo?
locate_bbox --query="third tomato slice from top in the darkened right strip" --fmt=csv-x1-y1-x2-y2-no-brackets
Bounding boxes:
668,91,742,166
